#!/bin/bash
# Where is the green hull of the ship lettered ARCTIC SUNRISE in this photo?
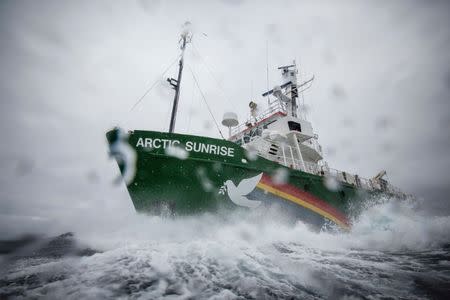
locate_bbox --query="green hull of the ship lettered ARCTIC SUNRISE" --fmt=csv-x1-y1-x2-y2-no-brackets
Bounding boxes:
107,130,366,228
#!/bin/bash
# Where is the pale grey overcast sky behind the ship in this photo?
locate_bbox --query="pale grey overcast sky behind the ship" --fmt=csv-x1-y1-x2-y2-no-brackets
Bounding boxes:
0,0,450,238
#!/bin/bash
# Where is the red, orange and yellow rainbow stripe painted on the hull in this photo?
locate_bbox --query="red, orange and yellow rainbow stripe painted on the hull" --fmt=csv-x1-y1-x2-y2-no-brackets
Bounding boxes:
257,174,350,230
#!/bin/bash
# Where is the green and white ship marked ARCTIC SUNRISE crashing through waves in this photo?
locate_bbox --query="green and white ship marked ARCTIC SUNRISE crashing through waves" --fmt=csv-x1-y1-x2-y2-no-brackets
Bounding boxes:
106,31,404,230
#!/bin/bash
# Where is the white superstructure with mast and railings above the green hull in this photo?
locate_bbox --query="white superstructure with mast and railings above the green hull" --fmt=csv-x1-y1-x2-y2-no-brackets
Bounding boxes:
225,61,404,192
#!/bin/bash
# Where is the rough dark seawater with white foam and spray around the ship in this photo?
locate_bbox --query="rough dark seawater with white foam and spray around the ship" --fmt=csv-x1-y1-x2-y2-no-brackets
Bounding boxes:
0,201,450,299
